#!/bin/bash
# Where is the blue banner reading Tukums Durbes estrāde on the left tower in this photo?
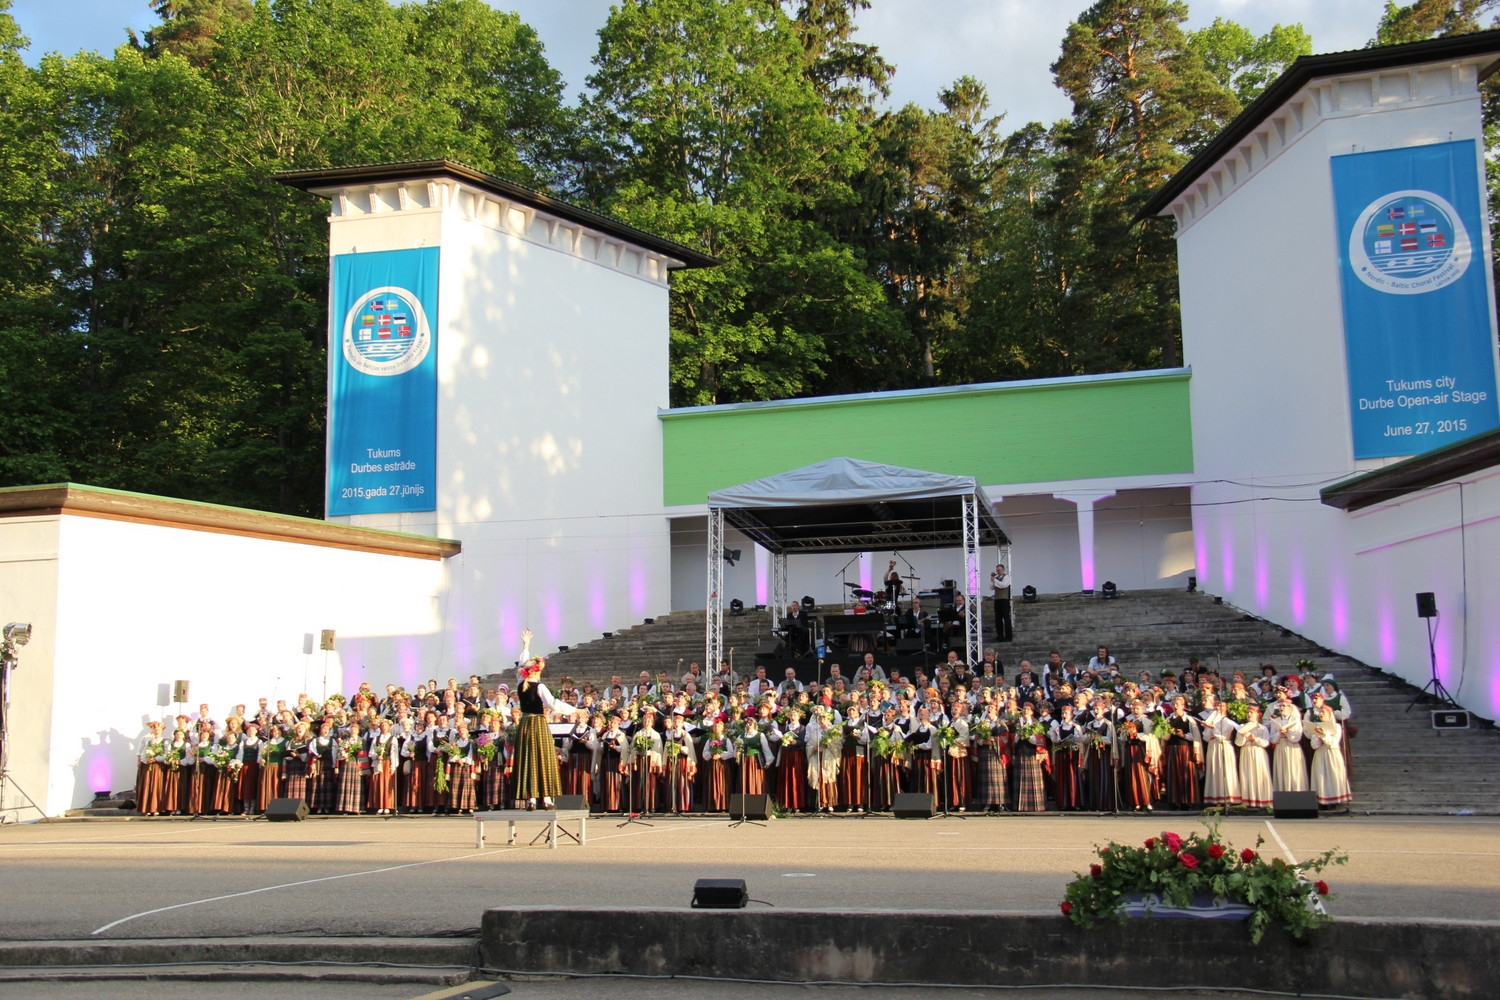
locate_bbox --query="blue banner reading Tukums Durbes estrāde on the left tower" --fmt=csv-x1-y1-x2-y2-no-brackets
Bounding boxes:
327,247,438,517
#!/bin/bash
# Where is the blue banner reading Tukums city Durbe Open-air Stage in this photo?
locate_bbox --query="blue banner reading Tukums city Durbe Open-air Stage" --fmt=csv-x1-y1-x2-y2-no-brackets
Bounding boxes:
1332,141,1500,459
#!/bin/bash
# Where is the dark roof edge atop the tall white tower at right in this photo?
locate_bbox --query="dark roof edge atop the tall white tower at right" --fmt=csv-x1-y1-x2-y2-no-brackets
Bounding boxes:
1136,30,1500,219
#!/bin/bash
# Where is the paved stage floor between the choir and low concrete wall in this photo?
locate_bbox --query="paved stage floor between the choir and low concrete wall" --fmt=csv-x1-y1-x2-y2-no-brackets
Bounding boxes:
0,814,1500,941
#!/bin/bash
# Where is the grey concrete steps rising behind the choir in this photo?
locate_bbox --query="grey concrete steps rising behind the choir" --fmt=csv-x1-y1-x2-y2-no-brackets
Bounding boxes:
501,591,1500,816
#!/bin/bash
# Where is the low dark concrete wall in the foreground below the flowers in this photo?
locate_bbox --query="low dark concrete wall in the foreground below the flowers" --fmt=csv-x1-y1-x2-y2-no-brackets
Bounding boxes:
480,907,1500,1000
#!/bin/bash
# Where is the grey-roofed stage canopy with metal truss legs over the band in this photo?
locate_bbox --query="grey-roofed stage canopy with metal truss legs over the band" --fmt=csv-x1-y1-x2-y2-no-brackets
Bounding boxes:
707,459,1010,664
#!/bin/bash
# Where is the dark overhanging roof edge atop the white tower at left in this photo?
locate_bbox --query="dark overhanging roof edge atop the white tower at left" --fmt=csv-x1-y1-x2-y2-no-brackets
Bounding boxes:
282,159,720,271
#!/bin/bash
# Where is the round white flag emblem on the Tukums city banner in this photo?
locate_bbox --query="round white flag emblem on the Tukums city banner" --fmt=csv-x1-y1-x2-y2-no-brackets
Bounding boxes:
1349,190,1473,295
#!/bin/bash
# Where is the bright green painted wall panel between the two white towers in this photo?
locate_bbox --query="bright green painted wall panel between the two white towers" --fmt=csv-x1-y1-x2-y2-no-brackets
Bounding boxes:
662,369,1193,505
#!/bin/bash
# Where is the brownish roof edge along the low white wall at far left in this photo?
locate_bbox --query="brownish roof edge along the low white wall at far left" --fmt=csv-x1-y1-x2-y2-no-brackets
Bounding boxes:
0,483,464,559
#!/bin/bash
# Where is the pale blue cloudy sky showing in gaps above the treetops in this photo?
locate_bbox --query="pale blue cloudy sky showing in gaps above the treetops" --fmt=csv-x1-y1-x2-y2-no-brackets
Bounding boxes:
11,0,1385,127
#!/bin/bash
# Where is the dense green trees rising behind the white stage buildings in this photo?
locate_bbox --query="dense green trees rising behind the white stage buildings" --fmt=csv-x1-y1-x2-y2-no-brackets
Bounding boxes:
0,0,1464,516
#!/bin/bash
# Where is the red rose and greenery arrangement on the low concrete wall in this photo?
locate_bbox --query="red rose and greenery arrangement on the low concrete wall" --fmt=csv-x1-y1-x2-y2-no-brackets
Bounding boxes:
1062,825,1349,943
